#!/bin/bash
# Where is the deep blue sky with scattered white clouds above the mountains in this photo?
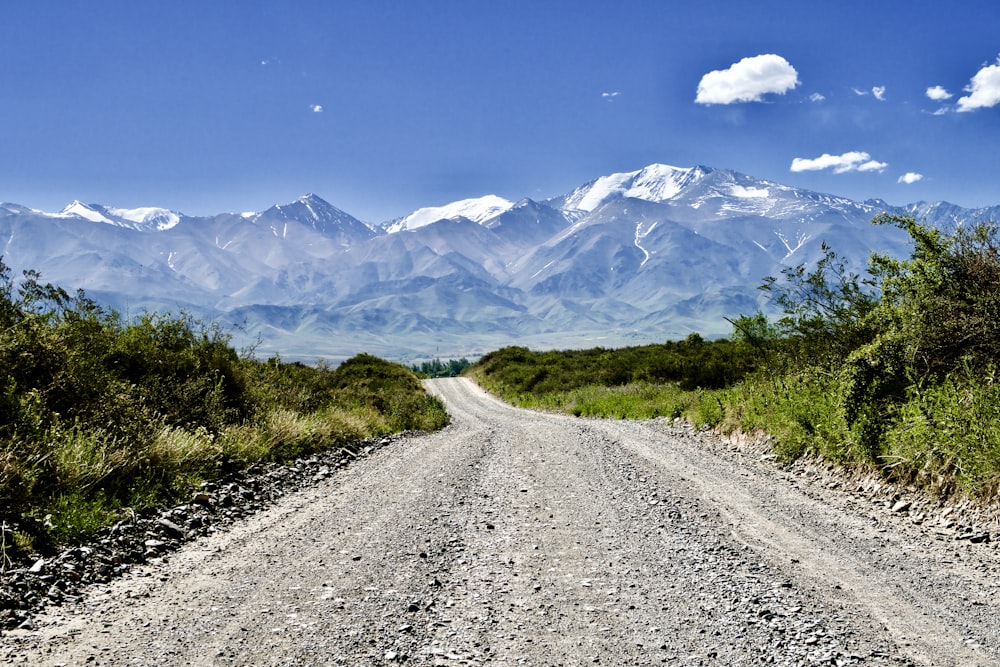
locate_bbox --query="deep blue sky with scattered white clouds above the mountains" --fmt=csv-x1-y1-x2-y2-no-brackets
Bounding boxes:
0,0,1000,222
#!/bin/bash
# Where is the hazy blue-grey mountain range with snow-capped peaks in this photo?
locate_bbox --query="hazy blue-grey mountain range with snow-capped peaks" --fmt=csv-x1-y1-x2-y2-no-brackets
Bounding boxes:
0,164,1000,360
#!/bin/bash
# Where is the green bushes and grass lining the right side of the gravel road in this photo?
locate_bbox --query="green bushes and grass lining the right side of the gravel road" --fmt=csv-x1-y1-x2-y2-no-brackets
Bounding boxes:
470,215,1000,499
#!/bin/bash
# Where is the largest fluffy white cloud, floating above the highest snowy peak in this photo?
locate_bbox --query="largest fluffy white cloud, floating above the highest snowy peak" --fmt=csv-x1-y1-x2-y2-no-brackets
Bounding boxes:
694,53,799,104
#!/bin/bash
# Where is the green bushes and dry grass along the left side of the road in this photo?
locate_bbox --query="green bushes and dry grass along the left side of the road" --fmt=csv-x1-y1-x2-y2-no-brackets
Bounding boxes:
0,262,448,558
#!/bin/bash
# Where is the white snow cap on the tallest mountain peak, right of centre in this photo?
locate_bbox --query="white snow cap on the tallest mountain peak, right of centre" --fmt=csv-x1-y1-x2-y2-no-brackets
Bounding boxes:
563,164,707,212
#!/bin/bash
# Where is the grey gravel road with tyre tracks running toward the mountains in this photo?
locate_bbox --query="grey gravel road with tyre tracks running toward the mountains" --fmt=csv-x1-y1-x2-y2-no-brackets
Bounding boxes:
0,379,1000,665
